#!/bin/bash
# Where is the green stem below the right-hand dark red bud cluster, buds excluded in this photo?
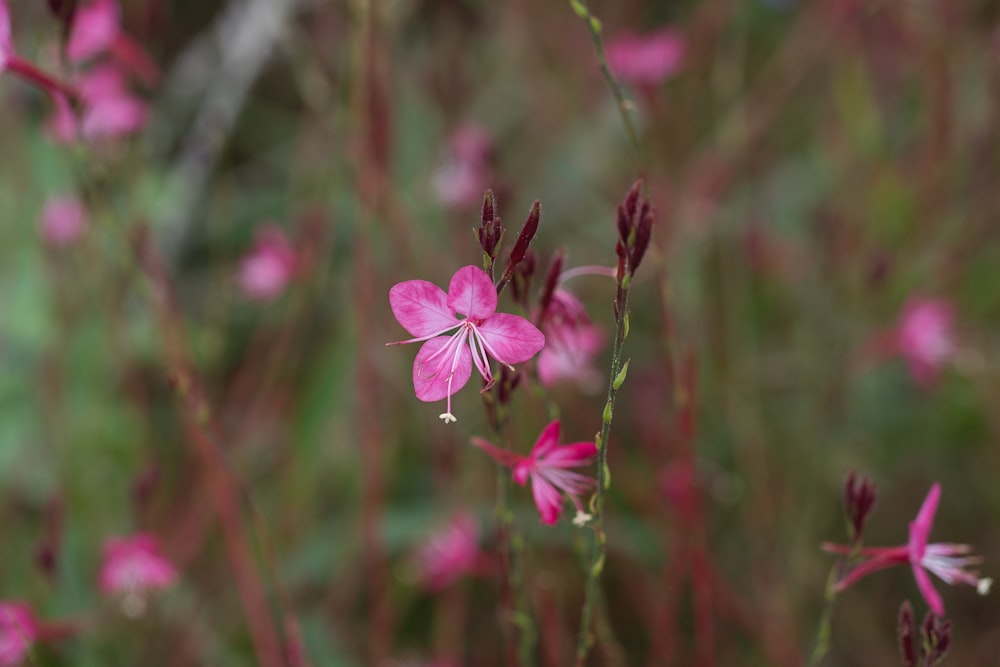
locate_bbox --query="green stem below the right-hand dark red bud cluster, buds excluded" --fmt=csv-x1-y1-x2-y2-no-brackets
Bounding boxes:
576,283,629,667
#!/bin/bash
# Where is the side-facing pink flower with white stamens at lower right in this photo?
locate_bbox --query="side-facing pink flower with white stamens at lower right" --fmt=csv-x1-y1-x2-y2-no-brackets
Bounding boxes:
823,482,993,616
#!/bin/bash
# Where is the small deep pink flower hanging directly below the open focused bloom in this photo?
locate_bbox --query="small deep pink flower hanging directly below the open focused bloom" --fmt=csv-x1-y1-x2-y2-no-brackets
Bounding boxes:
472,419,597,526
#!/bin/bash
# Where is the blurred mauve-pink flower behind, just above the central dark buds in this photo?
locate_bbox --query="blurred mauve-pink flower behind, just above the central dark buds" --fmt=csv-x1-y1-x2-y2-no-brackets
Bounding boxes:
433,123,491,208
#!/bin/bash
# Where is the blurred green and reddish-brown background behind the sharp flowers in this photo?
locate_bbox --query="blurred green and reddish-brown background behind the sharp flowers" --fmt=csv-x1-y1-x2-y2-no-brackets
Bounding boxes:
0,0,1000,667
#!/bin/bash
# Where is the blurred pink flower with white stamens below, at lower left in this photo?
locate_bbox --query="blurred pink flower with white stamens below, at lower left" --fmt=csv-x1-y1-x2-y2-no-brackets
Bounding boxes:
99,534,177,616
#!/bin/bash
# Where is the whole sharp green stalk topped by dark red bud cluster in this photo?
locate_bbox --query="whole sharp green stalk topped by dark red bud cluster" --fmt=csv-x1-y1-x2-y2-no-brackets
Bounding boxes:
574,181,653,667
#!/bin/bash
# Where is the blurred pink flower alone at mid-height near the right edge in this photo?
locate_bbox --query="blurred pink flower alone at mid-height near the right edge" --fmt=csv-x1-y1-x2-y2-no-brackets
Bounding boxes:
896,299,956,386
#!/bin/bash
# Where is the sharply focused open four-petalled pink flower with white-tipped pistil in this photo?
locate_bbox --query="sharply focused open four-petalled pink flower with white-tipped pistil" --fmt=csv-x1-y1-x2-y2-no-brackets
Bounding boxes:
387,266,545,423
